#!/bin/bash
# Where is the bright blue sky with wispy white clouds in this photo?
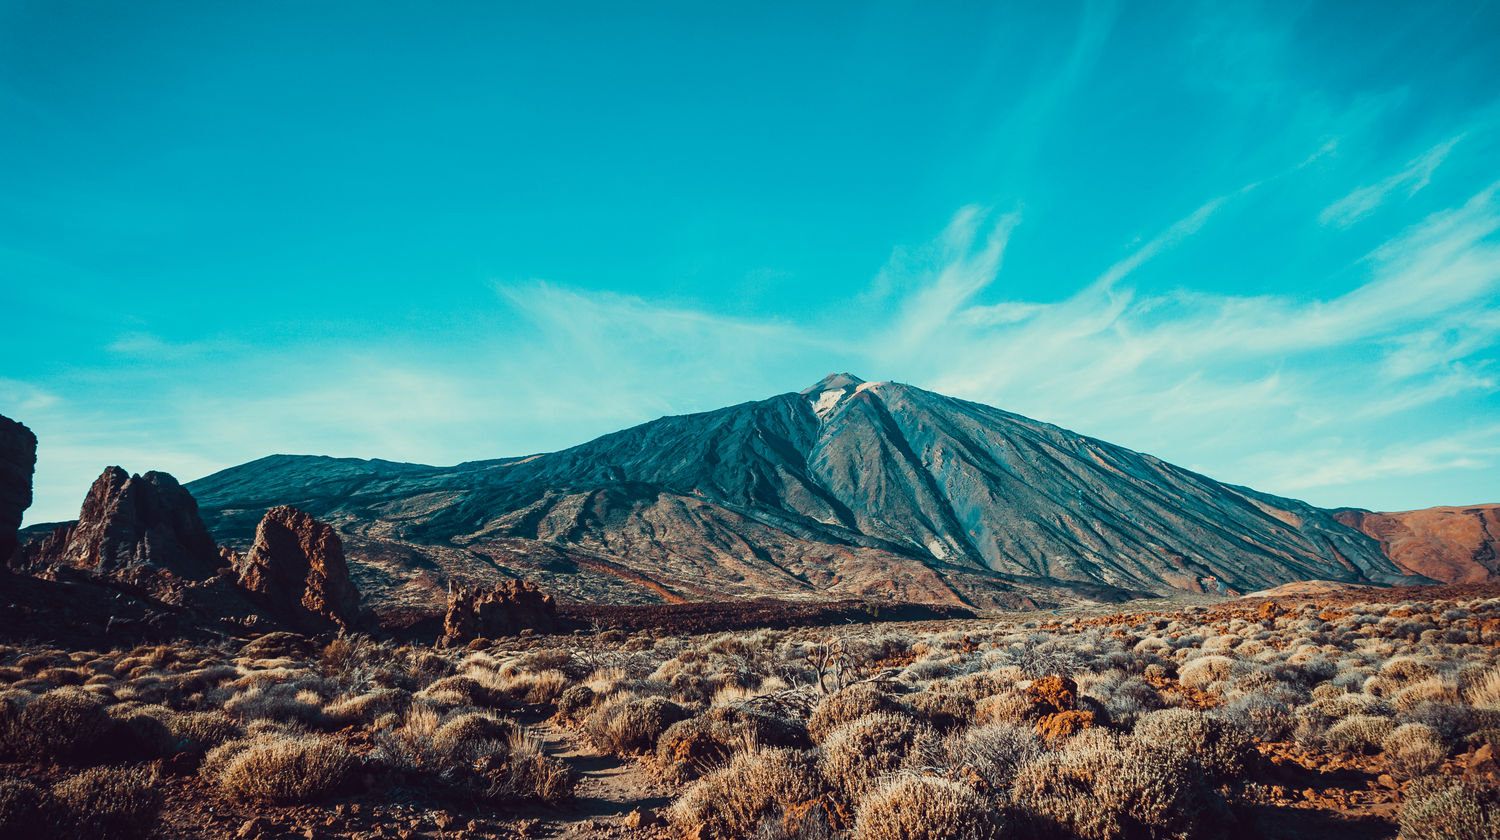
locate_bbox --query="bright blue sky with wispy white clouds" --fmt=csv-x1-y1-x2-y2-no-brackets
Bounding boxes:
0,0,1500,522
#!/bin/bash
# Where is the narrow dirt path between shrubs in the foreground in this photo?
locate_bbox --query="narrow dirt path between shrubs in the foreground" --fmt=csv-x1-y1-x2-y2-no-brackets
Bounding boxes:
533,723,672,839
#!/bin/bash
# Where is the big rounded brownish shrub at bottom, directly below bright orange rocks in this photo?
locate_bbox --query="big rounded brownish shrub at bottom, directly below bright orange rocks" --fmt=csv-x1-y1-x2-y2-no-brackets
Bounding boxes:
1013,729,1206,840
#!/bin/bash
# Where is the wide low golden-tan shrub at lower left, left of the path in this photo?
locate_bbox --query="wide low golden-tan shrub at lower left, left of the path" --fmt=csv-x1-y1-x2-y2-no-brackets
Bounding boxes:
204,732,356,806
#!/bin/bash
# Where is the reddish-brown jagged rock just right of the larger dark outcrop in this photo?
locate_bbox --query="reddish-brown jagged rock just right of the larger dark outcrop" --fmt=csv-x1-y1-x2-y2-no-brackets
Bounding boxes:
236,504,360,633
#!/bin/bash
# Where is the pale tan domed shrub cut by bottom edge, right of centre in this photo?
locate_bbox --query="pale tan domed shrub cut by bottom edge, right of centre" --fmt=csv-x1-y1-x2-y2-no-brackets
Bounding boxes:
854,776,1005,840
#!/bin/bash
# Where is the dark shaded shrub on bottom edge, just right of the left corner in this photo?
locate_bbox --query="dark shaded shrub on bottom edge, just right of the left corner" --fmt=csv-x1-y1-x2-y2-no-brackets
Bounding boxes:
53,767,162,840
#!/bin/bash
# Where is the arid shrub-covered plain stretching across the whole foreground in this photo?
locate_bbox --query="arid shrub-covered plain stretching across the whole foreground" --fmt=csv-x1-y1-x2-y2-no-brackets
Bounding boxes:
0,585,1500,840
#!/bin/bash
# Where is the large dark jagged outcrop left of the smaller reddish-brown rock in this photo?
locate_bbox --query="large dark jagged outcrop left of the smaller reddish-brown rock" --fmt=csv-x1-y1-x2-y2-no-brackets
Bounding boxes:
23,467,219,584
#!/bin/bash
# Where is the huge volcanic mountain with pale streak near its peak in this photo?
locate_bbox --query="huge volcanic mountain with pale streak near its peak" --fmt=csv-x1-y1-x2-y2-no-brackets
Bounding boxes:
188,374,1424,606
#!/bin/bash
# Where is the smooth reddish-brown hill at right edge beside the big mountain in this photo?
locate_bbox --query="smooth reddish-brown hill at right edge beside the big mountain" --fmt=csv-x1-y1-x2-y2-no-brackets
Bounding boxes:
1335,504,1500,584
